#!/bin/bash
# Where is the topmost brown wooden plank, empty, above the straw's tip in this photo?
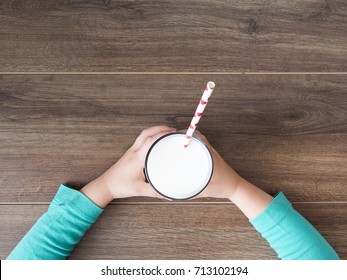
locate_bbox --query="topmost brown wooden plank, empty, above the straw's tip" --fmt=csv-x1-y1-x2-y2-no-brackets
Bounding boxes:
0,0,347,72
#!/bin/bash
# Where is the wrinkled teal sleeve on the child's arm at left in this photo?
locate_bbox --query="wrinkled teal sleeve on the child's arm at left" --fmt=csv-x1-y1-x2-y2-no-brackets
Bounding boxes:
7,185,103,260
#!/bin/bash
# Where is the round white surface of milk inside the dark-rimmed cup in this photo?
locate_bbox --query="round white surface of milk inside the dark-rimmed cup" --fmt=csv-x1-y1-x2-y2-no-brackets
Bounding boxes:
147,134,213,199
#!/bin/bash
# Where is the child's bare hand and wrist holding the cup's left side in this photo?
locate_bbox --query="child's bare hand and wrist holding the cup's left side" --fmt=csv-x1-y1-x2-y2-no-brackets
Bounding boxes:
81,126,176,207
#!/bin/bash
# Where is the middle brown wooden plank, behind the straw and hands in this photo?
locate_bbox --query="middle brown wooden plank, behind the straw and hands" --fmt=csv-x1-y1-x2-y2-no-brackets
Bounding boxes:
0,75,347,203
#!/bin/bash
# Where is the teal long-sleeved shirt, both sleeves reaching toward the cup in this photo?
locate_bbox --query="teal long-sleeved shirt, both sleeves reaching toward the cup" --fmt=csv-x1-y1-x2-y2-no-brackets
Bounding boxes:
7,185,339,260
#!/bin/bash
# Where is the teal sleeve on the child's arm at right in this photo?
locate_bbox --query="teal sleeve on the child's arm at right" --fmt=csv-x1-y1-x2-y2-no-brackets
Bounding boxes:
250,193,339,260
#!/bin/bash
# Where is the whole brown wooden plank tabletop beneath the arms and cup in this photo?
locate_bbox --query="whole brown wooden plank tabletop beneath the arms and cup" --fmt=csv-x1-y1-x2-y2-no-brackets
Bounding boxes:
0,0,347,259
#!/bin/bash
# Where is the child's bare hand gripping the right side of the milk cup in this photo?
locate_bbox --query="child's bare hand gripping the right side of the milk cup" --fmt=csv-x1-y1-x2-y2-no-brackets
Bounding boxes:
195,131,242,200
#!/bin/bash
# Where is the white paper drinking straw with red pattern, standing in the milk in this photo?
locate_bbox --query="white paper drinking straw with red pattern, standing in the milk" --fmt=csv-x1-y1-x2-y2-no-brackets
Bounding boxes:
184,81,216,148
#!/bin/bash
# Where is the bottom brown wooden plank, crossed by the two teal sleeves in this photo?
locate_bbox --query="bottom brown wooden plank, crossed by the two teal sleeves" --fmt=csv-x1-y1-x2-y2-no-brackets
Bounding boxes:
0,203,347,259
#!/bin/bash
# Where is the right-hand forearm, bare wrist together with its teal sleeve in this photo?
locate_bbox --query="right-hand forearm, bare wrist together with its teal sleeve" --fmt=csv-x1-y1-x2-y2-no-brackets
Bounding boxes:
232,179,339,260
